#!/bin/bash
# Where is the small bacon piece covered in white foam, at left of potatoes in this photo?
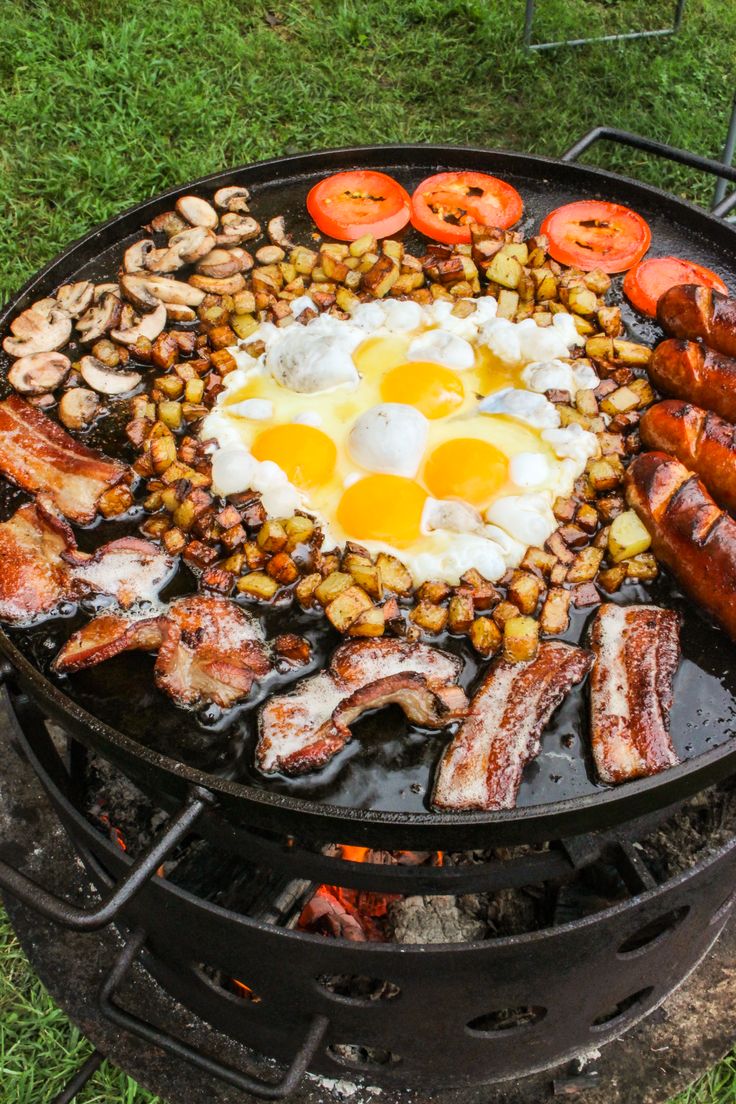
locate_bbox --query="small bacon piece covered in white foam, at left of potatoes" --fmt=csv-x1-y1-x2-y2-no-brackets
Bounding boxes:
64,537,175,609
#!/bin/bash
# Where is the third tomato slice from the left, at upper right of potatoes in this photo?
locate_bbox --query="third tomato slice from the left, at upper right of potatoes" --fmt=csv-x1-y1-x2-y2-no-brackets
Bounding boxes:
541,200,652,273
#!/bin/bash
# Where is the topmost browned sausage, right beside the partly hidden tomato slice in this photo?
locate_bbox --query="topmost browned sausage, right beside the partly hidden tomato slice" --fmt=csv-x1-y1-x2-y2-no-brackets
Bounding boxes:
657,284,736,357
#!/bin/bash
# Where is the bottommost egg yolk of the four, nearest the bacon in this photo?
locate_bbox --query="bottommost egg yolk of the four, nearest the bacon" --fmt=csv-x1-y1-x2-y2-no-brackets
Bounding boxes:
338,475,427,548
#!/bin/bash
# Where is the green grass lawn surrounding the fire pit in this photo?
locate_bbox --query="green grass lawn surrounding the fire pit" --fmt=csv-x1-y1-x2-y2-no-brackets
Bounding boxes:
0,0,736,1104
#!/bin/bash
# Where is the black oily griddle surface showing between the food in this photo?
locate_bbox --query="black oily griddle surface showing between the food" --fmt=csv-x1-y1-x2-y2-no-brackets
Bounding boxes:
0,147,736,822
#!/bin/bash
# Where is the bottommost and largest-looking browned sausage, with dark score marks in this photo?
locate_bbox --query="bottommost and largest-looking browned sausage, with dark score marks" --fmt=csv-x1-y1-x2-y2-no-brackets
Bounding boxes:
626,453,736,640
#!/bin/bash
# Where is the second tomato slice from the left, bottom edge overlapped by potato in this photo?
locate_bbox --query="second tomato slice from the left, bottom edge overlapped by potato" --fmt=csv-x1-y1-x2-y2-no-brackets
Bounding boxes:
412,172,524,244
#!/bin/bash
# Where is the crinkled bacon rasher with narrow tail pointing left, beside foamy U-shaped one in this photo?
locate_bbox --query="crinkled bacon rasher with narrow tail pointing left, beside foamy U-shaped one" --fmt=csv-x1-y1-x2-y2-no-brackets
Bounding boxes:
53,595,271,709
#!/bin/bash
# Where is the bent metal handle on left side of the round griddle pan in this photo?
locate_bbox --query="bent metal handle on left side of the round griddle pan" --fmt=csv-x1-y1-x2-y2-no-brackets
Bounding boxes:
0,789,212,932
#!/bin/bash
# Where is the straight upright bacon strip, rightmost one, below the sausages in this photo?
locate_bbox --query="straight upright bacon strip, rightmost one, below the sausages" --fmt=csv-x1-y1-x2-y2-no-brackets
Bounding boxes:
590,603,680,783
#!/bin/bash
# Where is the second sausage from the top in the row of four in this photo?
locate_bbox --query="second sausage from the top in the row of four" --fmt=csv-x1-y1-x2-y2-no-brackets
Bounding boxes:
649,338,736,422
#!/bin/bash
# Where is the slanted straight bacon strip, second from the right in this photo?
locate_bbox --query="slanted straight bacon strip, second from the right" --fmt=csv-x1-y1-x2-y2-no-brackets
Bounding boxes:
433,640,593,811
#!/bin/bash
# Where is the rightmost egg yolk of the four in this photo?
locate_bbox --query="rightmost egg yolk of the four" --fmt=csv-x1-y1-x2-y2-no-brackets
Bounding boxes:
424,437,508,506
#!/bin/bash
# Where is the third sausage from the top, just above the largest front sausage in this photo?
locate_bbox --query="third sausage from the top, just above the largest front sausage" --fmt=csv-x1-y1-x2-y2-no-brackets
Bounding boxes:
639,399,736,513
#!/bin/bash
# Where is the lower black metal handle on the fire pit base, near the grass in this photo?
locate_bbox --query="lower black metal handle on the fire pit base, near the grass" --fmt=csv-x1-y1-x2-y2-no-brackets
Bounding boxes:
99,928,330,1101
